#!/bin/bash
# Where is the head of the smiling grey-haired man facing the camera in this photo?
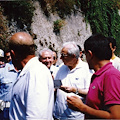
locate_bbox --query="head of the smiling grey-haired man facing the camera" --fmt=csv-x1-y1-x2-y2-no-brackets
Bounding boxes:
39,48,53,69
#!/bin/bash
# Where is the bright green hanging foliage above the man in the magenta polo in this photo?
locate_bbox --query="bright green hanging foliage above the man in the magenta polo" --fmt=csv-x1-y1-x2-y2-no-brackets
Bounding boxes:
81,0,120,54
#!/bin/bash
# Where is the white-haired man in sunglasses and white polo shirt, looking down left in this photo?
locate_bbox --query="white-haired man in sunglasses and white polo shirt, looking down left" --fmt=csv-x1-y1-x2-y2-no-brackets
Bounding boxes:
54,42,91,120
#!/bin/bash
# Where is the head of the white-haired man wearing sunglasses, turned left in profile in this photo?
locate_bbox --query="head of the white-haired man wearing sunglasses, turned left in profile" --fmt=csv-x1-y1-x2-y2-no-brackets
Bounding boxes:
61,42,80,67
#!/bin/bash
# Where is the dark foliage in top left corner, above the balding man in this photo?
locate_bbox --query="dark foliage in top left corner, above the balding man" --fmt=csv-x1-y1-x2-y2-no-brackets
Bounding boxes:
0,0,34,30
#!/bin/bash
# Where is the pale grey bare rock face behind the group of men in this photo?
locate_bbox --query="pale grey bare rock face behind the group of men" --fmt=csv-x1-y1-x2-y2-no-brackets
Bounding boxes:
31,2,92,64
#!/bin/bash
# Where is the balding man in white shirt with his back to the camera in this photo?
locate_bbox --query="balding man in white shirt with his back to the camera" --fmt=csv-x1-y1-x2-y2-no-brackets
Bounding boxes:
9,32,54,120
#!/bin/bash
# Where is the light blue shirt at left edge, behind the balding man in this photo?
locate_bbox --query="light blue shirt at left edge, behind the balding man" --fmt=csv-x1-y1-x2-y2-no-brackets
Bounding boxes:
0,62,18,101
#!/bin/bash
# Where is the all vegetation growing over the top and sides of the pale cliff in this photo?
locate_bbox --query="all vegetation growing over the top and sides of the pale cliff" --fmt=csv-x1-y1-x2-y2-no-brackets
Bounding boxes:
0,0,120,53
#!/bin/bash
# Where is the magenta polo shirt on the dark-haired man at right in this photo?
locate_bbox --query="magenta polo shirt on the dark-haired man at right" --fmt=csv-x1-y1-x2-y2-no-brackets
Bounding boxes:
86,62,120,118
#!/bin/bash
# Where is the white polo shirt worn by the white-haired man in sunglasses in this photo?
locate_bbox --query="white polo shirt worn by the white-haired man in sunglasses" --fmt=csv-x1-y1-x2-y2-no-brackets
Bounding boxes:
54,59,91,120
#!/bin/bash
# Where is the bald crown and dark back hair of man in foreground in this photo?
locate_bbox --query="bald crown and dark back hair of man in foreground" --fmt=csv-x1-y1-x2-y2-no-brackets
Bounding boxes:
9,32,35,58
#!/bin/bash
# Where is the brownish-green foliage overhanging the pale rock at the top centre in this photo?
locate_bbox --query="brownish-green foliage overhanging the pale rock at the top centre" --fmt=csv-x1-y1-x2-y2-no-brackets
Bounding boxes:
38,0,77,18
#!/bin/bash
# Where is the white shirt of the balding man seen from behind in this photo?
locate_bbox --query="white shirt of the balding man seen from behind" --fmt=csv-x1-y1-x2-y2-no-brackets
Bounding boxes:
9,57,54,120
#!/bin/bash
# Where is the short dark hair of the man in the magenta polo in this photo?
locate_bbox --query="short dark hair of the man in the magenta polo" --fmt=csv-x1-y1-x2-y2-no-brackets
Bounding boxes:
84,34,112,60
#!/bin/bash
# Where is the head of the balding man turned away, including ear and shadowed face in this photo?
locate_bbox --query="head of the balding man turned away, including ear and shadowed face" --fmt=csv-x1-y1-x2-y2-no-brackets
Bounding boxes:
9,32,35,69
